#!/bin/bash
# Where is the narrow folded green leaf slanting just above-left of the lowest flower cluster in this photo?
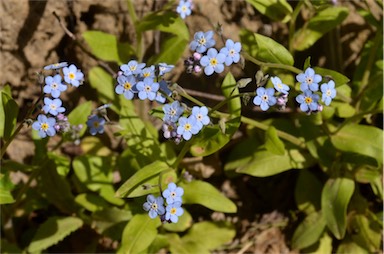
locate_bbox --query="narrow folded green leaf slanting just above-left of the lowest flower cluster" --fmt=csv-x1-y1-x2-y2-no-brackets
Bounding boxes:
116,161,169,197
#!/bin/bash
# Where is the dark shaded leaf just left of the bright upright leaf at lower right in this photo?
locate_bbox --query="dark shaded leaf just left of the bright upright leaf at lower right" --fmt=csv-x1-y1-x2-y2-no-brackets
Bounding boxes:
295,169,323,214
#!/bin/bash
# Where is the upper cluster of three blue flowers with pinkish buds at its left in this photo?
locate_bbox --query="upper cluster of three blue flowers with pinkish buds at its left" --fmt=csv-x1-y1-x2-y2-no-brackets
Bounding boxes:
184,31,241,76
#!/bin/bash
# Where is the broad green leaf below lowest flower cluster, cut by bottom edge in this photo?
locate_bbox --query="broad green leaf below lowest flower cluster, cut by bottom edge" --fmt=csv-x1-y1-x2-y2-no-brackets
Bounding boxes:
117,214,161,254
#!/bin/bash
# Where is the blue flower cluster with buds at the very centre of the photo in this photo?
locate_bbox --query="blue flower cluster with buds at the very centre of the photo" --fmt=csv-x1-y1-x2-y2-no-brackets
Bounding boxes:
162,101,210,143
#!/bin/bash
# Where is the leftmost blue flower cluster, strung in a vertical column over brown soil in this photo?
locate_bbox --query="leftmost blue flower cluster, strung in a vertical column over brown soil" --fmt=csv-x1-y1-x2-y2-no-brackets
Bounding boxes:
32,62,84,138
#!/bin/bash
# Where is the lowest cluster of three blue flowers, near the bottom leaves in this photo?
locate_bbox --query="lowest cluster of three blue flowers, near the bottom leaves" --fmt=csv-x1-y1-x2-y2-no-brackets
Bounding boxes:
143,183,184,223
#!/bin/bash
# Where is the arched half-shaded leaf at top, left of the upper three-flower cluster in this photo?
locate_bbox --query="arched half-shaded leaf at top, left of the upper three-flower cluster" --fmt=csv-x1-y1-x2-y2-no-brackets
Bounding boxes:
136,11,189,41
